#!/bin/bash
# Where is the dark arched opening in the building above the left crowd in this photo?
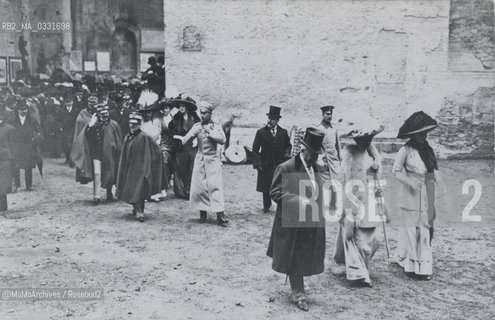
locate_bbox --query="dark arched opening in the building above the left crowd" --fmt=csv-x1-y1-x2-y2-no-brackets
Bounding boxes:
110,27,137,77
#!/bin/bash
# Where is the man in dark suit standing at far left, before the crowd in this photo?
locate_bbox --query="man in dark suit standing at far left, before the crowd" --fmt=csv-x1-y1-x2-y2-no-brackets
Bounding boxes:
11,98,40,191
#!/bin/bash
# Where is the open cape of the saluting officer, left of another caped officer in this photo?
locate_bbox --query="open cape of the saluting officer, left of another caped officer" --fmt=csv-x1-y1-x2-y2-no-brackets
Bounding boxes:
70,120,122,188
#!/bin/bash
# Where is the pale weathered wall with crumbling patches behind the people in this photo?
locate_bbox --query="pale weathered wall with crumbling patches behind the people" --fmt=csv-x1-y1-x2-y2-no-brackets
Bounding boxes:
164,0,494,156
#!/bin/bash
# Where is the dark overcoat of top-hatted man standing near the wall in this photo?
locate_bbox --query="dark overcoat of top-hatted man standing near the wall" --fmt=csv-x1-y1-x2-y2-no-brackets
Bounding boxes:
252,126,292,193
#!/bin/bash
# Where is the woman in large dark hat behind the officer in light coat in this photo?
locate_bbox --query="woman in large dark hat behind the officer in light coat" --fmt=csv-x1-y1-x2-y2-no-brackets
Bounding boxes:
168,97,201,199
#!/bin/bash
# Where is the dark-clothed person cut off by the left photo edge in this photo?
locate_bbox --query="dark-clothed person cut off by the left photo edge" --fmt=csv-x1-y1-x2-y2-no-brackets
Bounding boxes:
0,103,14,211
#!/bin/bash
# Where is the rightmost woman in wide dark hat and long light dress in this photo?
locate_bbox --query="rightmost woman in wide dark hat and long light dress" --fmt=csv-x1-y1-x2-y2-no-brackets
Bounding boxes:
393,111,438,280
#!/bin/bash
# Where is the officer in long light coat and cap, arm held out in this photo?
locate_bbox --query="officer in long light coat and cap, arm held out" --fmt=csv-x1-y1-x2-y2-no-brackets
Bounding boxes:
174,102,229,225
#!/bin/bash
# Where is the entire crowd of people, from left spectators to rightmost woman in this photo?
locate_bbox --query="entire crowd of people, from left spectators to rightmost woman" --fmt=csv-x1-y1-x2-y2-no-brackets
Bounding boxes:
0,63,444,311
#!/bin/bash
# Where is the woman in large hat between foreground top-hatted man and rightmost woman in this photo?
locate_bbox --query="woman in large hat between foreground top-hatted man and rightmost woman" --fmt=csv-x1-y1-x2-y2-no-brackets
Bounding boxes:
334,114,385,287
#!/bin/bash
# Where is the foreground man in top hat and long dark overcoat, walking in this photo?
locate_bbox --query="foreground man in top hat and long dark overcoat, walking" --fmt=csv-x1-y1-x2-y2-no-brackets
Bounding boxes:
267,128,325,311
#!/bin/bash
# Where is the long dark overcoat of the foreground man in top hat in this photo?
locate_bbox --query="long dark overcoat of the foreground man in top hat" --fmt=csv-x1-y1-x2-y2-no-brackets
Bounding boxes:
267,154,325,276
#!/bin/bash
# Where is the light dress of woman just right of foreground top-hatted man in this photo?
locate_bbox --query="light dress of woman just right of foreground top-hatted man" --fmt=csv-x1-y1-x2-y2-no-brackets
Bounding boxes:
334,145,381,283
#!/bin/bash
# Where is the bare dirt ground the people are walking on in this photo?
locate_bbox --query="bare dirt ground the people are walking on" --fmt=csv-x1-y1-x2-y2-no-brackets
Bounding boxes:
0,159,495,320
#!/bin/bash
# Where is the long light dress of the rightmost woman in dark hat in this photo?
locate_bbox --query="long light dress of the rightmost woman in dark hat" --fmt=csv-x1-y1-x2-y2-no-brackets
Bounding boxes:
393,146,437,275
